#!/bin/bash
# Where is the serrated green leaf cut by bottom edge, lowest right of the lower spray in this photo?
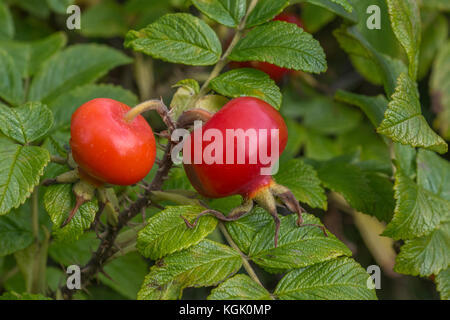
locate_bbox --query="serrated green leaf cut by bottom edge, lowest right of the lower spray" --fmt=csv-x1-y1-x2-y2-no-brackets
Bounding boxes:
274,258,377,300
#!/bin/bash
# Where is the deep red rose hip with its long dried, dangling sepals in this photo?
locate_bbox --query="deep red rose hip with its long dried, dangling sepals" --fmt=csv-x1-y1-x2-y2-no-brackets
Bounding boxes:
183,97,326,247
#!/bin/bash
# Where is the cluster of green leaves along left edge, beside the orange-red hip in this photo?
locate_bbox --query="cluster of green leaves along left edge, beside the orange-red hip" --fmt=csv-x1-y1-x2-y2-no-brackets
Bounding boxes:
0,0,138,298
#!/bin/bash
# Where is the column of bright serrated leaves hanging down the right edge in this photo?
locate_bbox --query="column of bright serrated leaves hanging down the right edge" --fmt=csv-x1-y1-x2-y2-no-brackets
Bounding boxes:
335,0,450,299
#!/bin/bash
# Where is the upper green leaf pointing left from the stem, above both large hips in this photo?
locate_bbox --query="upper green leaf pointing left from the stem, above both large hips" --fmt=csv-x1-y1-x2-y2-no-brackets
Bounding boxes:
125,13,222,66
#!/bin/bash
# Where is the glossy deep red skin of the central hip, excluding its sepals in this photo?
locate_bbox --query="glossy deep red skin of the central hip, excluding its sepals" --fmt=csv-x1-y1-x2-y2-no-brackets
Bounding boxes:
184,97,288,198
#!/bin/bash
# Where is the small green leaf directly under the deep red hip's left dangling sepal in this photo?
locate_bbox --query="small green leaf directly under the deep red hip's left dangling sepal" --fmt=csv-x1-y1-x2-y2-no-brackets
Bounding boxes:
137,206,217,260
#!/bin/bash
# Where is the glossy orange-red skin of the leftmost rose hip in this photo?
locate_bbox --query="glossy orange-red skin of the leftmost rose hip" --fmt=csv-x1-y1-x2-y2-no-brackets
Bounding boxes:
70,98,156,185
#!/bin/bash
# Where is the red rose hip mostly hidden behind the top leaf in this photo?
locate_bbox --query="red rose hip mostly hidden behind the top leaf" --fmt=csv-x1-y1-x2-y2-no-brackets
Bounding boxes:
230,12,303,82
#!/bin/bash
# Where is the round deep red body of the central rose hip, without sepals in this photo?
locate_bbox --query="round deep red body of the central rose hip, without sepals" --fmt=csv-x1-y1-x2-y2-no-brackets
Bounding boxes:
184,97,287,198
